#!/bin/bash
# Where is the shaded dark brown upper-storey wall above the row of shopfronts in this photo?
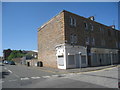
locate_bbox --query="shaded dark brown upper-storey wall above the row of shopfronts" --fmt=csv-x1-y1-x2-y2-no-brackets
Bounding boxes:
65,11,120,49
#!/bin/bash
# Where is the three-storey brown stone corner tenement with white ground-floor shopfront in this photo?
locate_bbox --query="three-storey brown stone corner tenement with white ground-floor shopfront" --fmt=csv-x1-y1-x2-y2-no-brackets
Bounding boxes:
38,10,120,69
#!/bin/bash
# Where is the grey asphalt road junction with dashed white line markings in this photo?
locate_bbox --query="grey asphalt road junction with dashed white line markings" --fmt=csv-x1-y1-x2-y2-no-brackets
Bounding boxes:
0,65,118,88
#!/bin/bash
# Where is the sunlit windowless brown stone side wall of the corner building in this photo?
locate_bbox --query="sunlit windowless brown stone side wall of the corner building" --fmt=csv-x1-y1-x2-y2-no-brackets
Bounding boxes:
38,12,64,68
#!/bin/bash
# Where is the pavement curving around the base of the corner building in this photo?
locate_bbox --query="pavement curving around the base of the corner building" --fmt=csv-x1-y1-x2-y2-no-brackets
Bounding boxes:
31,64,120,74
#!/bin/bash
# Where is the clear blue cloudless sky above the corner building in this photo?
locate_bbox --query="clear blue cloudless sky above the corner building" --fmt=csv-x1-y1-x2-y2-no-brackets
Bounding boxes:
0,2,118,56
